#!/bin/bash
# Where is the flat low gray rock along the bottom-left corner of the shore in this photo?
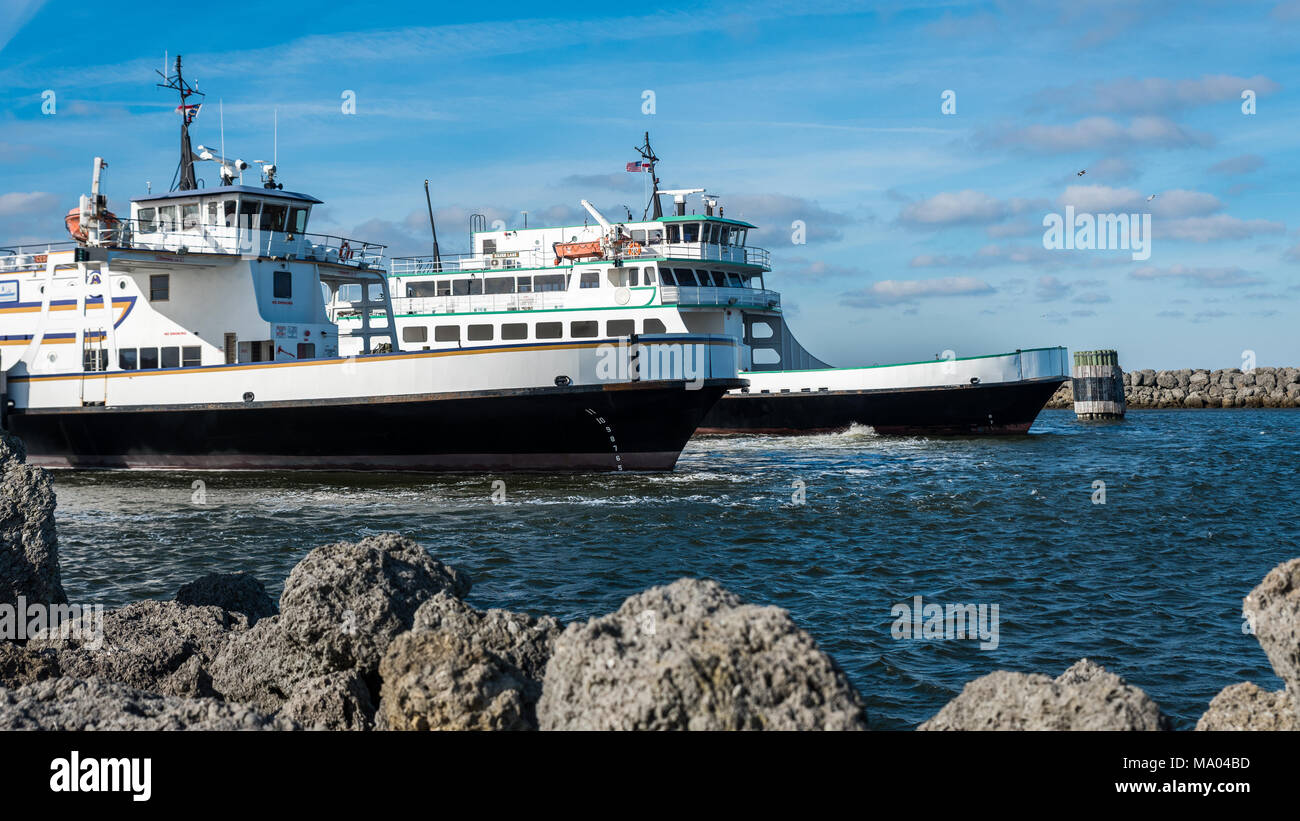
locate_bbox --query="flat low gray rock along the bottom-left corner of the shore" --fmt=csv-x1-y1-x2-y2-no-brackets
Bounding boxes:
0,678,298,730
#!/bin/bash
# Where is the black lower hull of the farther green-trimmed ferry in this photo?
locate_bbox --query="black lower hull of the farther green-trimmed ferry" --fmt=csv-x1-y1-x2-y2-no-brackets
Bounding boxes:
698,378,1065,435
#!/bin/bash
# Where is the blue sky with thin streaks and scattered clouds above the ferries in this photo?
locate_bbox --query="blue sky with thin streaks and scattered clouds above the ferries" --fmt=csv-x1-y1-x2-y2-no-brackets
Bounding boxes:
0,0,1300,368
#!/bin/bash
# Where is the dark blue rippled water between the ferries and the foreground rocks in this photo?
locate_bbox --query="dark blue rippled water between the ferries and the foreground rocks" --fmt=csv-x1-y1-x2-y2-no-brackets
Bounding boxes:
45,411,1300,729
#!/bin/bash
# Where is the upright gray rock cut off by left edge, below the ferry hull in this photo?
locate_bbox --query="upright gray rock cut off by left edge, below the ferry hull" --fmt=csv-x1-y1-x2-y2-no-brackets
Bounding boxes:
0,431,68,604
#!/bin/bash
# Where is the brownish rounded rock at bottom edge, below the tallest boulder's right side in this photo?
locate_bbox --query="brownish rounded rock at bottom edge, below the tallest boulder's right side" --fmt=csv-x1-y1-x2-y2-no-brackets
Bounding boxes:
380,627,536,730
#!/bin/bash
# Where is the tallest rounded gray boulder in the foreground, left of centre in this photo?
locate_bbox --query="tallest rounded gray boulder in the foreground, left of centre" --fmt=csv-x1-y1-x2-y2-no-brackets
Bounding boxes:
280,533,469,676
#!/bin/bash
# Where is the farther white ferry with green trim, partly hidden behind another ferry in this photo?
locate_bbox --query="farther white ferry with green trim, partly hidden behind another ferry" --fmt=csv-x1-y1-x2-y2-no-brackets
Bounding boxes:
348,135,1069,434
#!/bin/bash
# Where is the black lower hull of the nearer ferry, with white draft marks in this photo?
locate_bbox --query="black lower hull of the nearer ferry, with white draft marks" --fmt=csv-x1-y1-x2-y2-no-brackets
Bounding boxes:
7,379,744,472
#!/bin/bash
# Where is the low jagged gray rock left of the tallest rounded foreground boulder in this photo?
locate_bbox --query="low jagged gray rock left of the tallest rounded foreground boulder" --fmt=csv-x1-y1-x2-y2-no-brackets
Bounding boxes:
27,600,248,696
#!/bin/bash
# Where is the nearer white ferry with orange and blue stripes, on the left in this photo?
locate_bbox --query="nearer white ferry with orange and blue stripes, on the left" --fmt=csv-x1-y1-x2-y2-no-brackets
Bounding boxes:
0,57,744,472
